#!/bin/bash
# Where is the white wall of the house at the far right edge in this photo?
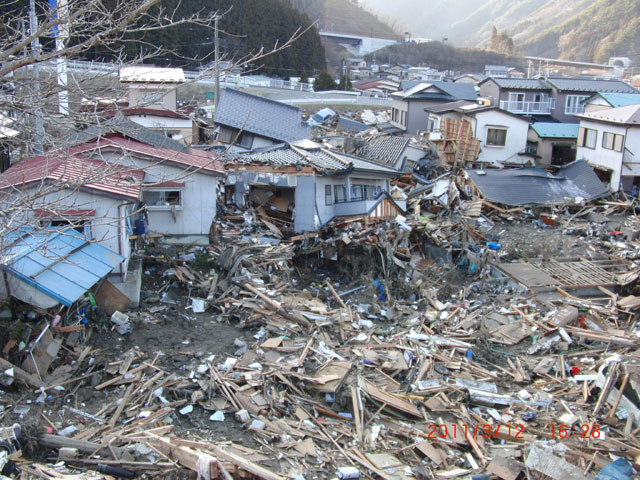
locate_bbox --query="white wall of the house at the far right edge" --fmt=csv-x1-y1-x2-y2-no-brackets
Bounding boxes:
576,118,640,192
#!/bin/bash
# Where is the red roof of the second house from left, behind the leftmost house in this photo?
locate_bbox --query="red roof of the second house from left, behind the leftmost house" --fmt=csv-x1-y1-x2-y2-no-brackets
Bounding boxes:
69,135,224,175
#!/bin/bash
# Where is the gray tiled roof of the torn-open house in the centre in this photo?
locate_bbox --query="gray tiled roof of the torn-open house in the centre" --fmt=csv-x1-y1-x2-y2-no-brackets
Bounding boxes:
225,144,400,175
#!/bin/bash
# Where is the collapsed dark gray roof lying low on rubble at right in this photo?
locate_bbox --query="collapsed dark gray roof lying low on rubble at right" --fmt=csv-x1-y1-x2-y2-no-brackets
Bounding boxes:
466,160,609,206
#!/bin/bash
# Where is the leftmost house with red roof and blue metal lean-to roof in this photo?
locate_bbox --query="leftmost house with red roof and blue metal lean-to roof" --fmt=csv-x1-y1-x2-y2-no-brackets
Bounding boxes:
0,152,144,308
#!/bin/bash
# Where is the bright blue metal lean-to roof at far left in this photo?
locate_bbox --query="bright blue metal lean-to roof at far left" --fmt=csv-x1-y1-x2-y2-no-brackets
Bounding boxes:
0,230,124,306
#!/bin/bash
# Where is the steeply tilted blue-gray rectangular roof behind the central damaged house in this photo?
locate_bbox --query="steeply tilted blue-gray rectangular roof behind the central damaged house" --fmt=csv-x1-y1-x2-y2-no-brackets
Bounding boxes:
214,88,310,142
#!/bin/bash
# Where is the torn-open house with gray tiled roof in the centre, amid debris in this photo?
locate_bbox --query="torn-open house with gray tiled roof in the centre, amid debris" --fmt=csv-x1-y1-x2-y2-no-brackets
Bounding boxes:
225,140,402,233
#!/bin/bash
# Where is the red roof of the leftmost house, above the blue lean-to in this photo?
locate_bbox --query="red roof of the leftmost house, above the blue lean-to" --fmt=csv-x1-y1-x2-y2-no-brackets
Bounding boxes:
0,152,144,200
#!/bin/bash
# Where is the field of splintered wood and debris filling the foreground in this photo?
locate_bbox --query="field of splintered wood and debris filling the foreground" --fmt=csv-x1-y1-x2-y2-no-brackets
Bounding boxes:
0,192,640,480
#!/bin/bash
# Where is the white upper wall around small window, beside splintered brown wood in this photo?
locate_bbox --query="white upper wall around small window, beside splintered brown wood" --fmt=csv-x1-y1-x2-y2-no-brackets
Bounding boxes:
469,110,529,164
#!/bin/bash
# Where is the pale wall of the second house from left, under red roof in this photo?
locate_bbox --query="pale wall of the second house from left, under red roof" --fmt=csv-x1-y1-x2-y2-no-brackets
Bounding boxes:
91,152,218,236
